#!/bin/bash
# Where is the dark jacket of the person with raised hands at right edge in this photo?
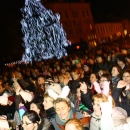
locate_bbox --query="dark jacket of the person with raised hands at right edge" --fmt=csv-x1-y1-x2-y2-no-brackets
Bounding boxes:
112,88,130,116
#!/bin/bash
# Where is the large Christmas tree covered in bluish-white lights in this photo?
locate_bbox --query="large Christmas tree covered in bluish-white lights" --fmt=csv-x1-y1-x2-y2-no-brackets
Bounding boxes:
21,0,70,63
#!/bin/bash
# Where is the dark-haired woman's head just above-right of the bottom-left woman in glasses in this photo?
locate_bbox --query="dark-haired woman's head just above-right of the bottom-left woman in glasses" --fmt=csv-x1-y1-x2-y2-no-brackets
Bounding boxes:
30,97,44,114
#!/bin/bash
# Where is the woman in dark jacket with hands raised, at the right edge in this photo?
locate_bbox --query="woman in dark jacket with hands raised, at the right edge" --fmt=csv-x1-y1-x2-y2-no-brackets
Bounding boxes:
112,70,130,116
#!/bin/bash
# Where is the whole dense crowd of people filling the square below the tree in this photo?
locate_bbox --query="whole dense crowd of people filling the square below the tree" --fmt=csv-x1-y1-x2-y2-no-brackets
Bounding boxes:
0,42,130,130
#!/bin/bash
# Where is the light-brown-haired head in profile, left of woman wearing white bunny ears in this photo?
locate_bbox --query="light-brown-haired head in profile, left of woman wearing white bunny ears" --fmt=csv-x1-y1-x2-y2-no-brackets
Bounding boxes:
43,93,54,110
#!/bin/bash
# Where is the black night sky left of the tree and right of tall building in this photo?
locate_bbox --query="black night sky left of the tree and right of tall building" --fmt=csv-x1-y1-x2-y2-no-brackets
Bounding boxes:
0,0,130,62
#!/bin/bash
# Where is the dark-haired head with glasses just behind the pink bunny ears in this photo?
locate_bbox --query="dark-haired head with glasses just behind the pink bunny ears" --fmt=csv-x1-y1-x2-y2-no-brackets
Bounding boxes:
99,74,111,88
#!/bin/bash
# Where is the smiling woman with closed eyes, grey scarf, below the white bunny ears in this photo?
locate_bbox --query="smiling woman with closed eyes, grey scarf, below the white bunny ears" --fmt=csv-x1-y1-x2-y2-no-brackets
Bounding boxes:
51,98,90,130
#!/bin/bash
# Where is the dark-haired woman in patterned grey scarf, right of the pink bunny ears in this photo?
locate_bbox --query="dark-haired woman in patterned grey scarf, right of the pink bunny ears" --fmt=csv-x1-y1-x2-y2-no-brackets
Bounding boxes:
111,66,122,90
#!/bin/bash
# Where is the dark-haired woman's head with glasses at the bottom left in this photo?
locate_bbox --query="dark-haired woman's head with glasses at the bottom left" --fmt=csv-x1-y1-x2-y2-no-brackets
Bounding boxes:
22,110,40,130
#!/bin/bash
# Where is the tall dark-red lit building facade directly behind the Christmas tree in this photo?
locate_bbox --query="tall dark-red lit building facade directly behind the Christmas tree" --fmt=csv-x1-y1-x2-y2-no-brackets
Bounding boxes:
44,2,95,44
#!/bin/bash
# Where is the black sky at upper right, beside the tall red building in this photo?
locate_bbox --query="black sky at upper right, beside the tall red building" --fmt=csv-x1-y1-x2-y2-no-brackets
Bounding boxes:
89,0,130,21
